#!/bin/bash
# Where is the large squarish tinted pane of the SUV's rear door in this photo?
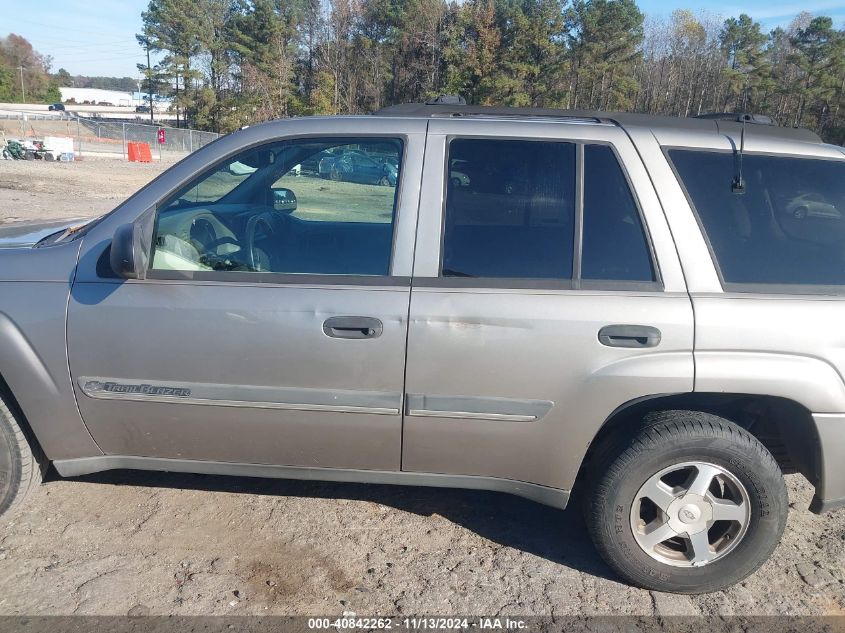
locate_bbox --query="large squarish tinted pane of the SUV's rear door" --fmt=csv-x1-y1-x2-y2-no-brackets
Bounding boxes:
442,139,575,279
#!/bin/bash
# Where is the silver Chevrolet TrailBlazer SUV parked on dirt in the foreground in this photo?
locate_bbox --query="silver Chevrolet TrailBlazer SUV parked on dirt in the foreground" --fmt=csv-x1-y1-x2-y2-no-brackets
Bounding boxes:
0,103,845,593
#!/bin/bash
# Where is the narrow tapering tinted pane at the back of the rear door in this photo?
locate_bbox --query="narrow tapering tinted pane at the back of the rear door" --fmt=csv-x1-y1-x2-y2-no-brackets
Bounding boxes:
581,145,654,281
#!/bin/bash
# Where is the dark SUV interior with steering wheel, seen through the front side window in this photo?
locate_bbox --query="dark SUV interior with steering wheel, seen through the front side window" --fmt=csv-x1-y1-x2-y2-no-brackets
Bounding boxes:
152,139,401,275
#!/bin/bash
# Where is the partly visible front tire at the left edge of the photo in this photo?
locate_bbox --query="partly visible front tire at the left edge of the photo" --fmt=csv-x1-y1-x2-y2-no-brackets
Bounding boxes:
0,398,43,516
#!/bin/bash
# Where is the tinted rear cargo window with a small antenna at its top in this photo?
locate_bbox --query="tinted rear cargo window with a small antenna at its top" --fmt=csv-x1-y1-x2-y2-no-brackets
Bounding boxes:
670,150,845,285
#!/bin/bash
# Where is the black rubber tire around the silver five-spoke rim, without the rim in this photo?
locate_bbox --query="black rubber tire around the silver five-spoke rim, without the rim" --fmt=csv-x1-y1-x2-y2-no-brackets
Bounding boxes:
584,411,789,594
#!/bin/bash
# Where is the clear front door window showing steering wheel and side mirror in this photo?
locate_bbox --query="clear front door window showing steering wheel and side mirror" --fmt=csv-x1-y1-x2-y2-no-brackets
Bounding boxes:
151,138,403,275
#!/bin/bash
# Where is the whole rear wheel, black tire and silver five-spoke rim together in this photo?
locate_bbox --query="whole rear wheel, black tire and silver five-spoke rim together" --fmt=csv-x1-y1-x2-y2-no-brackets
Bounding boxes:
587,411,788,593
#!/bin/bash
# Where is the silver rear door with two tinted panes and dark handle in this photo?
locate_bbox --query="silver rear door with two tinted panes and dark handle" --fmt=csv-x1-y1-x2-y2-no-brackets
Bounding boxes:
402,120,693,490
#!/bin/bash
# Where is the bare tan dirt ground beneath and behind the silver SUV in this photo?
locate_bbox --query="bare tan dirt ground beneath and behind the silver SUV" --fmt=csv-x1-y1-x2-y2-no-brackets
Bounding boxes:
0,161,845,616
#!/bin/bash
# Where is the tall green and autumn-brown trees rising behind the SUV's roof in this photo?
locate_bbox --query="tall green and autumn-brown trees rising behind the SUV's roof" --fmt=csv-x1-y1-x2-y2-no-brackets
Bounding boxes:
138,0,845,143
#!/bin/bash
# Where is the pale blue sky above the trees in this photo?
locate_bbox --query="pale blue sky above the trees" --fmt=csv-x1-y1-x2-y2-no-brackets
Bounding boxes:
0,0,845,77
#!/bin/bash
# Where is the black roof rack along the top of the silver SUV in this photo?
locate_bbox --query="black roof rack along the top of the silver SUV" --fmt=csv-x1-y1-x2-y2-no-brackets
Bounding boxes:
373,95,822,143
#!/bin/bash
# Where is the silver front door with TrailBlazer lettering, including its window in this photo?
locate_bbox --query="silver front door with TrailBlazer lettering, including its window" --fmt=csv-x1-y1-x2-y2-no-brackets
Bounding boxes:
68,123,425,470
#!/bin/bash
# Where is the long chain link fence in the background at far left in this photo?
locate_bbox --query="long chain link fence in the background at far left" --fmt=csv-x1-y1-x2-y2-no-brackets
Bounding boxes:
0,114,220,161
